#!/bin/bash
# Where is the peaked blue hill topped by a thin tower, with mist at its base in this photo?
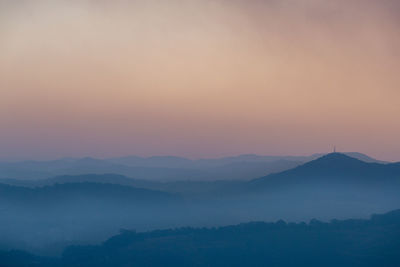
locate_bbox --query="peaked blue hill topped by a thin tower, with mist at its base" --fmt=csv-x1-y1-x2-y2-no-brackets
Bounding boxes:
232,153,400,224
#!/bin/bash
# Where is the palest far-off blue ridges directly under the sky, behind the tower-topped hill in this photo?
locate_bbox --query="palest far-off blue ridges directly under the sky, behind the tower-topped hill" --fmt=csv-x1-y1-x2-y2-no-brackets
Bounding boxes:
0,153,379,182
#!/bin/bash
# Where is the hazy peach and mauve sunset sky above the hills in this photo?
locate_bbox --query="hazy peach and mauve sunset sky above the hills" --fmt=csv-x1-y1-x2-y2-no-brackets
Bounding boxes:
0,0,400,161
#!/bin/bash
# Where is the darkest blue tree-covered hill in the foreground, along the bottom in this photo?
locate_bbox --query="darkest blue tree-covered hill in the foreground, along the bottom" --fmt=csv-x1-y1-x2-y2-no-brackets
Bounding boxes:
0,210,400,267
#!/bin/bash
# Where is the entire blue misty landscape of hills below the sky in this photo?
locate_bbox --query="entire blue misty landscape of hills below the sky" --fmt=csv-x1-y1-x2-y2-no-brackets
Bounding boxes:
0,153,400,266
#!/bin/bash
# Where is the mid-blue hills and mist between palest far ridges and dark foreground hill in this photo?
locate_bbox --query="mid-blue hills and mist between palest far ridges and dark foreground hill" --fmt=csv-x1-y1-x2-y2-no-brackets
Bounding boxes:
0,153,400,253
